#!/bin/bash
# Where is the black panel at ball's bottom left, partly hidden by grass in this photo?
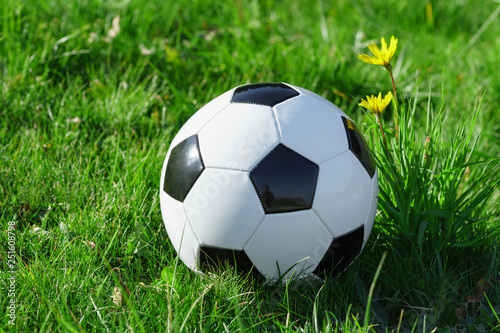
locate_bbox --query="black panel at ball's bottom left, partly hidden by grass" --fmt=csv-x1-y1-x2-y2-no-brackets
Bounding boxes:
199,246,263,278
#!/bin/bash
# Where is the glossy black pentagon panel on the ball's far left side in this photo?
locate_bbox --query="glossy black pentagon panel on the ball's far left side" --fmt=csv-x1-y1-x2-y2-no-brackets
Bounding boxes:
163,135,205,202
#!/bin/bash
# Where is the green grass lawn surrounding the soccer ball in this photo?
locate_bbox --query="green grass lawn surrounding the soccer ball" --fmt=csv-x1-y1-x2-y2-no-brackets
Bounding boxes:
0,0,500,332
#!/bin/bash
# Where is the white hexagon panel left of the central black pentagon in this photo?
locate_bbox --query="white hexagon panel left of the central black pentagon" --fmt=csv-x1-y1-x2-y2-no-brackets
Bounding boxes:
184,169,264,250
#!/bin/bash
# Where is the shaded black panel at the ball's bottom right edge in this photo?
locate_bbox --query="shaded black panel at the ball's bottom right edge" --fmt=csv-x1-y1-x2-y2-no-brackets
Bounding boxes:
313,225,365,278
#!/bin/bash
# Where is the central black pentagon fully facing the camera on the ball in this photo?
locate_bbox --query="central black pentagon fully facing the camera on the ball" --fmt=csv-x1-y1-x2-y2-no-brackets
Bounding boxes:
250,144,319,214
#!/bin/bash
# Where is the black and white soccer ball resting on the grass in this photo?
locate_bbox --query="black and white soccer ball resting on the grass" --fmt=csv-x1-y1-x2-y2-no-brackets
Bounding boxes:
160,83,378,281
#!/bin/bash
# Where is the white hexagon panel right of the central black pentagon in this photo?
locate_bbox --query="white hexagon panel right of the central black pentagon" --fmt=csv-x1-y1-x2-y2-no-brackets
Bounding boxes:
313,150,373,238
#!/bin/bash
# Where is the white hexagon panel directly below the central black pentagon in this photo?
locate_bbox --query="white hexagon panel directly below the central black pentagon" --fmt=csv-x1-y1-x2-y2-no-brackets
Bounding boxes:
245,210,333,280
